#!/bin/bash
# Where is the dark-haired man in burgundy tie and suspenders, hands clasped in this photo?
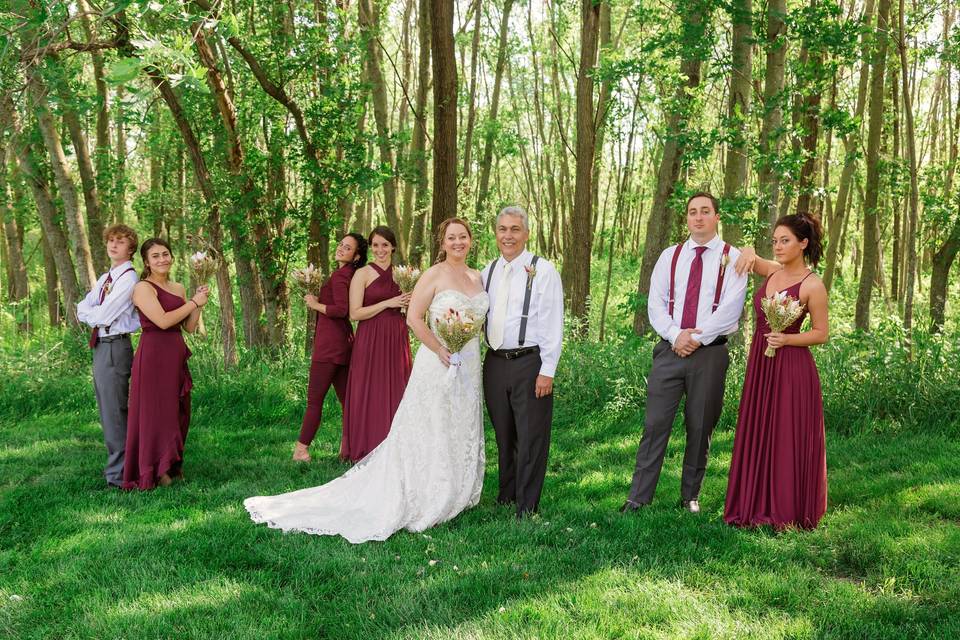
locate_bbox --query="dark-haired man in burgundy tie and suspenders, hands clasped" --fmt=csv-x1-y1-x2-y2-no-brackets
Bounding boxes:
620,192,747,513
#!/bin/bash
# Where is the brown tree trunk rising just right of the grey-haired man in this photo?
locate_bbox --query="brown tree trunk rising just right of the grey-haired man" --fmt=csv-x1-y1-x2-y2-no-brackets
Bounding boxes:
564,0,600,335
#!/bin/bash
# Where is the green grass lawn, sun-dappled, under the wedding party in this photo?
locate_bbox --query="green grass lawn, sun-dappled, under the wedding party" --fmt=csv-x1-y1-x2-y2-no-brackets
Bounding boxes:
0,344,960,639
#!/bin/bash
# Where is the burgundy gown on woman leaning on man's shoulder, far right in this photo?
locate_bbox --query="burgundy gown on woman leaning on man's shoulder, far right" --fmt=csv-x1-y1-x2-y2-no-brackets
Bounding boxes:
723,274,827,529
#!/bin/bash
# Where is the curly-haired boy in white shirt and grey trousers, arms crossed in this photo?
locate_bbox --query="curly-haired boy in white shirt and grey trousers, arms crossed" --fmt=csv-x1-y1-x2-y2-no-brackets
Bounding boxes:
77,224,140,487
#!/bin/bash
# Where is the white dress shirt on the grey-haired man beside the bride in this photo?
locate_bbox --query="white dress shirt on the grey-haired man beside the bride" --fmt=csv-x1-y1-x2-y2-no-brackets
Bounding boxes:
482,251,563,378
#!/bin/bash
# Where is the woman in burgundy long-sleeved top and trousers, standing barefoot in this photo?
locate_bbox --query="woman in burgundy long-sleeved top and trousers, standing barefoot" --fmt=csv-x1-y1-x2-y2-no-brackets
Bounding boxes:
293,233,367,462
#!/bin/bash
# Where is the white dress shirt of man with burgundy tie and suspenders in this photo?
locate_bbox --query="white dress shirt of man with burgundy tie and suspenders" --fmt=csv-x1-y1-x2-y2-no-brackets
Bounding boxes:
647,236,747,344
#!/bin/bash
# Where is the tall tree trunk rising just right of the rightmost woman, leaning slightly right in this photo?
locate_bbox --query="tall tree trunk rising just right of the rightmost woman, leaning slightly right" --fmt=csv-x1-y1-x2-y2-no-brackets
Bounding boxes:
855,0,890,331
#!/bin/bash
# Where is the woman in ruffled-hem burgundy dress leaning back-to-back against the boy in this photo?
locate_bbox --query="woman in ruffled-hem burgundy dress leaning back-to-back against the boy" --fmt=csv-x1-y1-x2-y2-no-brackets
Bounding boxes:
123,238,208,489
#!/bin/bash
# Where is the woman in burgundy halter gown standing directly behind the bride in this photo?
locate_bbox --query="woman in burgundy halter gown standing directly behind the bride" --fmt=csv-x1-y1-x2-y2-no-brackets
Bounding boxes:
340,227,413,462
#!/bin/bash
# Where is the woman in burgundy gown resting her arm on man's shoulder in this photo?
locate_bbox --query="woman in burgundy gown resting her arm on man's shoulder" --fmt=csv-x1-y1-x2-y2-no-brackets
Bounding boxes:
723,214,829,530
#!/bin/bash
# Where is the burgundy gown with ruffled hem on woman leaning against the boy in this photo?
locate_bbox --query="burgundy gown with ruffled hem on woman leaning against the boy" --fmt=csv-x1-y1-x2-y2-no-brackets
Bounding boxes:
123,280,193,489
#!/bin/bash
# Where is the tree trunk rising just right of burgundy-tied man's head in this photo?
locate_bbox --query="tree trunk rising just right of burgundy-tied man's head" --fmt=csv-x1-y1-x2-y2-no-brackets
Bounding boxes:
723,0,753,245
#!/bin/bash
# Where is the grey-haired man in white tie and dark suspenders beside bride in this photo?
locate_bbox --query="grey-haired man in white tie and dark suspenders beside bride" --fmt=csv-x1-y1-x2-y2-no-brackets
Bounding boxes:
483,206,563,519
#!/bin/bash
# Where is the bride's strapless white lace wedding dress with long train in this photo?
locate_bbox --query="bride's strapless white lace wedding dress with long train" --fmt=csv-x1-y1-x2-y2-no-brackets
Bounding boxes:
243,289,489,543
